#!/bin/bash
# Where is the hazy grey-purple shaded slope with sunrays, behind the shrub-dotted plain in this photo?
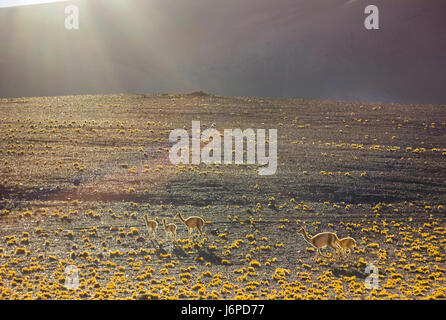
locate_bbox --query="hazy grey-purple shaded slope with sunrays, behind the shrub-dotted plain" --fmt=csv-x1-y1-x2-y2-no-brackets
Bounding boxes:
0,0,446,104
